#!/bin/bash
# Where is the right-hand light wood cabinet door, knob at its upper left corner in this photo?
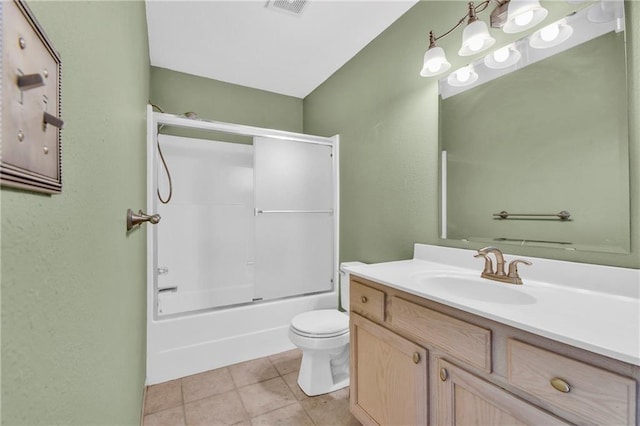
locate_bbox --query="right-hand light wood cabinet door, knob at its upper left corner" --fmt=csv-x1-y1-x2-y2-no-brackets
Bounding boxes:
434,359,568,426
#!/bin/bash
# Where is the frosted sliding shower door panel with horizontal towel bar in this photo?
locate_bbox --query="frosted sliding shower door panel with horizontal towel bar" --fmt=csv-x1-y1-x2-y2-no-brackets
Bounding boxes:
254,137,335,300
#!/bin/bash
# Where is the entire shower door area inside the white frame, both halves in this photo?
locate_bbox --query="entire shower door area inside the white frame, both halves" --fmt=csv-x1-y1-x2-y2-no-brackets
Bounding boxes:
152,135,336,316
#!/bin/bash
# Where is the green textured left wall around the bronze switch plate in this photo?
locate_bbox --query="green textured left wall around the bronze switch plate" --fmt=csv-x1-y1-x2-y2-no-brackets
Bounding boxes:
0,1,149,425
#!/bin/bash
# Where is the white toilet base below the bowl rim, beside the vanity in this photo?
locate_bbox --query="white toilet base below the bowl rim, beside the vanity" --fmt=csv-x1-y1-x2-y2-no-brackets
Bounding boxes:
298,344,349,396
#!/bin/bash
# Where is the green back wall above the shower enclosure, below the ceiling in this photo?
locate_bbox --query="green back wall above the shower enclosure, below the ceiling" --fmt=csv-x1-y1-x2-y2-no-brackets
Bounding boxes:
149,67,302,143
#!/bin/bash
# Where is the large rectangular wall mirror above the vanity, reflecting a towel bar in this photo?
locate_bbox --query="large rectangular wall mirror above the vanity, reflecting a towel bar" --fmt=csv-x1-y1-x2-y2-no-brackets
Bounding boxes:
439,1,630,253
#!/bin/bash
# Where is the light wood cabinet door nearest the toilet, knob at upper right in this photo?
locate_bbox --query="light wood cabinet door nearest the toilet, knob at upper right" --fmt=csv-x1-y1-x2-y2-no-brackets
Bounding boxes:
350,313,428,425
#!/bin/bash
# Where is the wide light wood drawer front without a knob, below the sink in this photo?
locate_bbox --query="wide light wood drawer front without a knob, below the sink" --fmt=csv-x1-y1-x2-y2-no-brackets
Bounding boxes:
390,297,491,373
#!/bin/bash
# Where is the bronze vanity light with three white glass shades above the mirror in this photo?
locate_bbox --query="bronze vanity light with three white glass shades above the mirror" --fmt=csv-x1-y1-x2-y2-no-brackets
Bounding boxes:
420,0,547,77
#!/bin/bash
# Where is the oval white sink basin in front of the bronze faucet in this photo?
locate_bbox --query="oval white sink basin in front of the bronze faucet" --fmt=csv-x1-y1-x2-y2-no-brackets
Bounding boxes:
418,273,536,305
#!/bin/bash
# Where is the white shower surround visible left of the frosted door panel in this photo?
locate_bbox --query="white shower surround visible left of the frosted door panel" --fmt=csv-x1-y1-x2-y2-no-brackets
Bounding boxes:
153,135,255,315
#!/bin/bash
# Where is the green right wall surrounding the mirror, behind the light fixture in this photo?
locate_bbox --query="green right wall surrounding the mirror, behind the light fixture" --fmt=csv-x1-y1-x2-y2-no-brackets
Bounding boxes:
304,1,640,268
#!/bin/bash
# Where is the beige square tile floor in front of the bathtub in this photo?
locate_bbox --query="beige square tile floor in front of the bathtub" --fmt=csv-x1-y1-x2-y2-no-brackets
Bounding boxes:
143,349,360,426
